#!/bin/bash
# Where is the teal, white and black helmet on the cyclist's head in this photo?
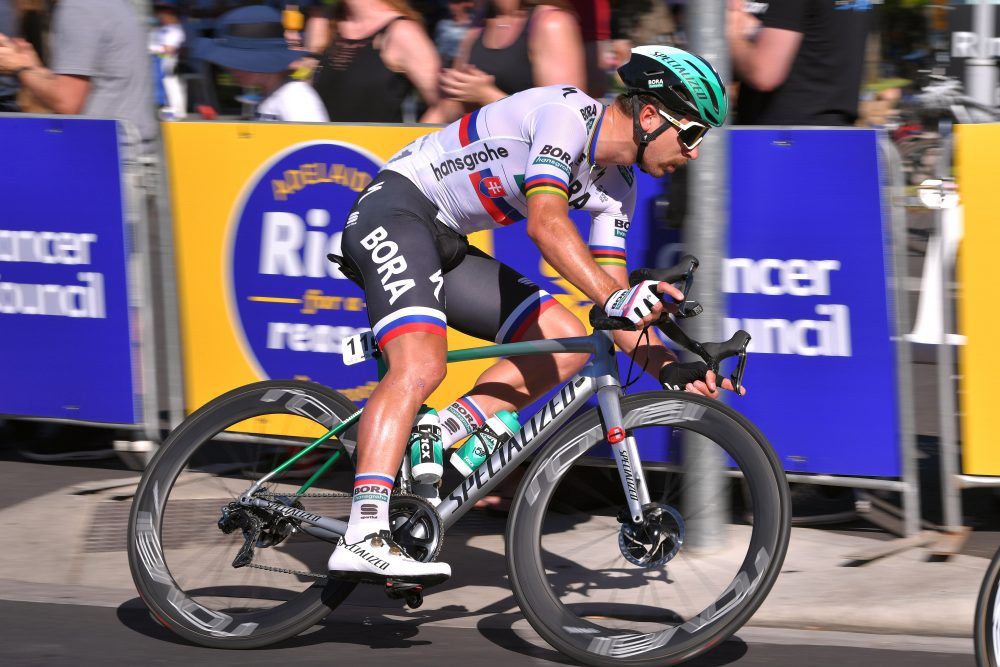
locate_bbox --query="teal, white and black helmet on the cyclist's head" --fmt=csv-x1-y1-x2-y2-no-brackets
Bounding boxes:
618,45,729,127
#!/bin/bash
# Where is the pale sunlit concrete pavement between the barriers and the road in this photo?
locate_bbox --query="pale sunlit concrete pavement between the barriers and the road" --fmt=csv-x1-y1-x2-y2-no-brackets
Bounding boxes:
0,454,988,638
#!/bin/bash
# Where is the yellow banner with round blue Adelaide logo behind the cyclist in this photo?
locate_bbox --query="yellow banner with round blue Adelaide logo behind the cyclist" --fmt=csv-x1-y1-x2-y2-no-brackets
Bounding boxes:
163,123,504,426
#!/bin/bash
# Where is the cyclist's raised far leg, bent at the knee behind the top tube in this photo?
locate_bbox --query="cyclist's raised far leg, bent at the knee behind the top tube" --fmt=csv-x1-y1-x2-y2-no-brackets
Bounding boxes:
445,248,589,416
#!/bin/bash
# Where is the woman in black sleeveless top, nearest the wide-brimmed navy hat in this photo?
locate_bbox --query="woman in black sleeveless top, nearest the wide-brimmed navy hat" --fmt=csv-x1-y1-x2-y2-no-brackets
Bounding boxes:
313,0,441,123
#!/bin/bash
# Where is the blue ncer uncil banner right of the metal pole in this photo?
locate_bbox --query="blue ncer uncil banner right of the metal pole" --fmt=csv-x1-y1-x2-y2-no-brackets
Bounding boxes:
724,129,901,477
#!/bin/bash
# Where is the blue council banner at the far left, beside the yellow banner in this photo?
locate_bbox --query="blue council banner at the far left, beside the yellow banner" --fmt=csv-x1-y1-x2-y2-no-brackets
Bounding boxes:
0,116,138,424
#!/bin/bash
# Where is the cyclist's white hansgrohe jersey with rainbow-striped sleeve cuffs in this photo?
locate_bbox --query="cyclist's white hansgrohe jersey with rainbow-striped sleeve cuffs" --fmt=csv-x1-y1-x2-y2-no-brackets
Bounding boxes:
385,86,635,266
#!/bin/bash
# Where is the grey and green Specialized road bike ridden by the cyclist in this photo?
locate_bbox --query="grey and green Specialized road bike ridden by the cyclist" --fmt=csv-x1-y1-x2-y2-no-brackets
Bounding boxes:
128,256,790,666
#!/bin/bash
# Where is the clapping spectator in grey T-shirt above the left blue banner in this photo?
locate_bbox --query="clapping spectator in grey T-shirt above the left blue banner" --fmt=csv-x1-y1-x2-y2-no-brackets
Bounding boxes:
0,0,157,153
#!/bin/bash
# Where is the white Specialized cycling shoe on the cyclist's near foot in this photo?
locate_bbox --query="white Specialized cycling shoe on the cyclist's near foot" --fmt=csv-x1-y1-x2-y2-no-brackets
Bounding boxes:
327,531,451,586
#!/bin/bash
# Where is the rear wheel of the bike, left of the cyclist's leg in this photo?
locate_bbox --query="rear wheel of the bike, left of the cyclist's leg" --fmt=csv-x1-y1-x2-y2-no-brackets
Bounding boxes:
128,381,357,648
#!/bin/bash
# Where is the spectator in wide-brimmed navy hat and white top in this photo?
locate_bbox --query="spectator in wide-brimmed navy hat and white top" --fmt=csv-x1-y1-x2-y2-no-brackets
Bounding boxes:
197,5,328,123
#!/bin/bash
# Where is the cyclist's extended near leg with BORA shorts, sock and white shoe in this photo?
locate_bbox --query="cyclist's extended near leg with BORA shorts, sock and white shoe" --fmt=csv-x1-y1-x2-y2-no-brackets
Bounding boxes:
329,172,451,584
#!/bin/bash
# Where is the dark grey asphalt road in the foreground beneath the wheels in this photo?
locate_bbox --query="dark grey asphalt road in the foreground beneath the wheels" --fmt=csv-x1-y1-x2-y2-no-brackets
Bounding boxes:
0,600,975,667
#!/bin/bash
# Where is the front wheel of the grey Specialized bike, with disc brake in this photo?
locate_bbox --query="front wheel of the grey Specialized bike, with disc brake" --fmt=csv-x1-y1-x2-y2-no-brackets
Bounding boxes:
507,391,791,667
